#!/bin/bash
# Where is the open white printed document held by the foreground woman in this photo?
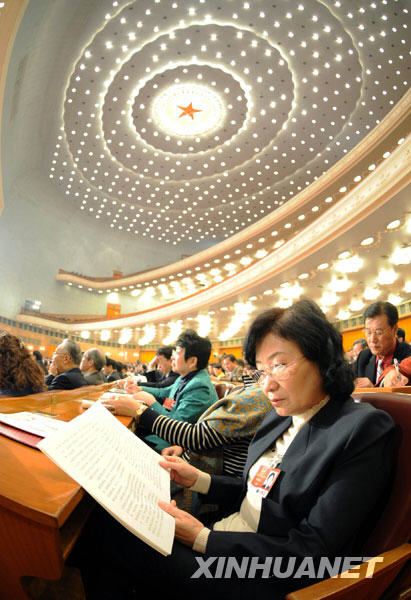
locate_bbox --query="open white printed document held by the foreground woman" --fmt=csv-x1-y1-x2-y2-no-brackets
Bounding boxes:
38,402,174,554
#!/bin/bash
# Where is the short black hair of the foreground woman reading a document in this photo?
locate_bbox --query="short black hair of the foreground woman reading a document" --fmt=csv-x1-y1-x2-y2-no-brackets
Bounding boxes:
243,298,354,400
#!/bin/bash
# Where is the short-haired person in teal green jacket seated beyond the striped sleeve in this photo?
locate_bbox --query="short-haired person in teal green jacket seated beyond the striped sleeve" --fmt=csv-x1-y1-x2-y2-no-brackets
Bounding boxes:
104,329,218,451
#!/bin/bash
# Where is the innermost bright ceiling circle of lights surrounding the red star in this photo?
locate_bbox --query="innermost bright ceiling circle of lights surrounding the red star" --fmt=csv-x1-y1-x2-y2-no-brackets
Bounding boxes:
132,65,247,154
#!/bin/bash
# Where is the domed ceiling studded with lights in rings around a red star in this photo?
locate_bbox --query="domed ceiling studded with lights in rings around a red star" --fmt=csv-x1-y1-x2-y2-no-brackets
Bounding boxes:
41,0,410,248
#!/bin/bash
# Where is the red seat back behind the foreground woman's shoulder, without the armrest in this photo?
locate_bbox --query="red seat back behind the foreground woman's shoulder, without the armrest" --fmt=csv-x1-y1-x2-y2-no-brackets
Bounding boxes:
353,392,411,556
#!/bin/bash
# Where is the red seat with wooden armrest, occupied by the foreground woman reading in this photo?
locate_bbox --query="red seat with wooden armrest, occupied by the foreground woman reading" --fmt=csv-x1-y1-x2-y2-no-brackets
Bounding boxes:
286,392,411,600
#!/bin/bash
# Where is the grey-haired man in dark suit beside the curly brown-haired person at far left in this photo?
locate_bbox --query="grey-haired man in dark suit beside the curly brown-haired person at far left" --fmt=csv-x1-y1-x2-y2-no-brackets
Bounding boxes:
46,339,89,390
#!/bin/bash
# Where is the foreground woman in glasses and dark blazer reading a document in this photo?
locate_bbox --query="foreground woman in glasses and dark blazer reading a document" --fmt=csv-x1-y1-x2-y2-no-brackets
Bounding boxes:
75,300,394,600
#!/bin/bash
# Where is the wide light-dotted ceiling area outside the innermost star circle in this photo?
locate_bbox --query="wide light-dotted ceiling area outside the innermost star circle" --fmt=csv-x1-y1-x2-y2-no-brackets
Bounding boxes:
54,1,405,244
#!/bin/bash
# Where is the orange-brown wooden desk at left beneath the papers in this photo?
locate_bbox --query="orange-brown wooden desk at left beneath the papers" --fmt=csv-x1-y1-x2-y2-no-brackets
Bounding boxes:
0,386,132,600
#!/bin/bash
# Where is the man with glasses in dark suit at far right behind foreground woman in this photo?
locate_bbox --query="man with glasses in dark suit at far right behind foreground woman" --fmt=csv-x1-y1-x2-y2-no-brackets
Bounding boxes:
355,302,411,387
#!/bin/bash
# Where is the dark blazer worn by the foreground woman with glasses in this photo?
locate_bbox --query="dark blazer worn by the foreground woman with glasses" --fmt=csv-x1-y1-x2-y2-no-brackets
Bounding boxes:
203,398,395,561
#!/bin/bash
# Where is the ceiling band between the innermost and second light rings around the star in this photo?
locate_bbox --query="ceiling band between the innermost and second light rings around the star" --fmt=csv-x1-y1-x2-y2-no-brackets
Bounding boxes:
103,25,294,181
